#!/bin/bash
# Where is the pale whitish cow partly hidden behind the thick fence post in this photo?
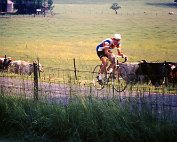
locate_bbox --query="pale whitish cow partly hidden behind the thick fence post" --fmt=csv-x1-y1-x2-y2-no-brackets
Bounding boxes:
8,60,43,76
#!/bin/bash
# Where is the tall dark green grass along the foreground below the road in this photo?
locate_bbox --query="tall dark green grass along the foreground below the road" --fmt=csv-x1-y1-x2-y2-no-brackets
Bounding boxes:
0,94,177,142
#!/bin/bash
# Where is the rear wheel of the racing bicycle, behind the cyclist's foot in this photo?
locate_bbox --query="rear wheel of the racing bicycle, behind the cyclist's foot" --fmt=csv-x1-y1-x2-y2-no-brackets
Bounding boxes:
92,65,104,90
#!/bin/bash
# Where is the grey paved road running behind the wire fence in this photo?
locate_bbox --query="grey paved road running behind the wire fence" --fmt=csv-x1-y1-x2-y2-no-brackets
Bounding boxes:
0,77,177,121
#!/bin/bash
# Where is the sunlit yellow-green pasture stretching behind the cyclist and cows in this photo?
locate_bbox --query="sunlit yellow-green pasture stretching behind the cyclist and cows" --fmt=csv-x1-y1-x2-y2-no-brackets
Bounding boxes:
0,0,177,66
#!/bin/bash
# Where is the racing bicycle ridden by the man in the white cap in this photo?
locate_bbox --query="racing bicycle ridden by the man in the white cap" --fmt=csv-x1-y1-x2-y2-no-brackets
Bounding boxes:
92,56,128,92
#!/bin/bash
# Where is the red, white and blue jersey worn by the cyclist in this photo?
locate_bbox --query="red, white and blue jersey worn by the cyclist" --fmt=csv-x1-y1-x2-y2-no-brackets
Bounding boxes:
96,38,120,52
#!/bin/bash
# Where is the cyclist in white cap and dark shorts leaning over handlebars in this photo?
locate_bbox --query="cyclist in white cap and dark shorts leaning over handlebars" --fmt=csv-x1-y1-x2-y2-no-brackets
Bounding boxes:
96,34,128,84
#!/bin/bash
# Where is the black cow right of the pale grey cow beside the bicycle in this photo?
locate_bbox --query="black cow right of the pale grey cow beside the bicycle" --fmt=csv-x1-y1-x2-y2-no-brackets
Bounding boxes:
136,60,166,86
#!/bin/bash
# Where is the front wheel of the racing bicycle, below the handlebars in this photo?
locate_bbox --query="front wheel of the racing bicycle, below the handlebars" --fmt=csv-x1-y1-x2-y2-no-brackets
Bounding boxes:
113,67,128,92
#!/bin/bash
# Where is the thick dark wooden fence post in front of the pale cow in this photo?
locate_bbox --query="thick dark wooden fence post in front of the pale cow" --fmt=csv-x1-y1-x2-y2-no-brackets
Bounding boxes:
33,62,38,101
